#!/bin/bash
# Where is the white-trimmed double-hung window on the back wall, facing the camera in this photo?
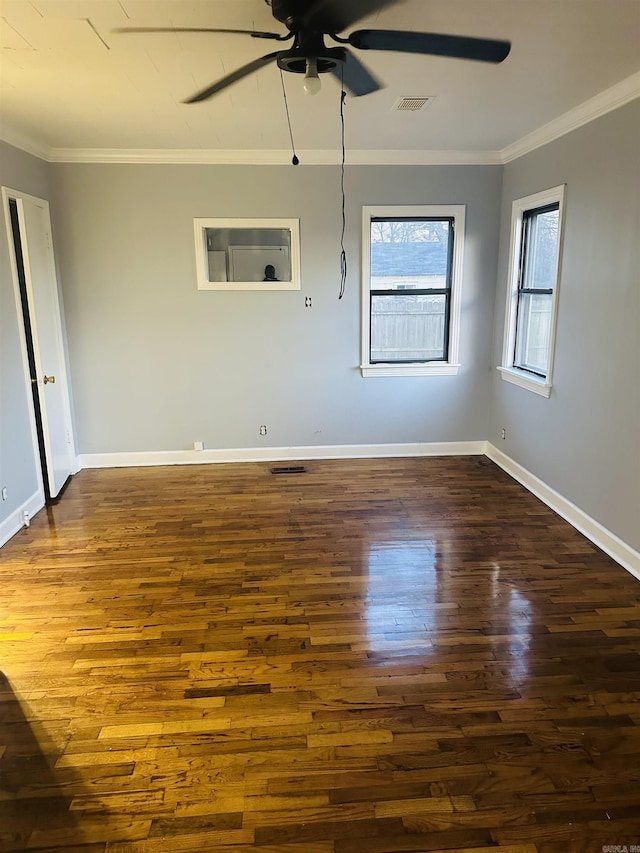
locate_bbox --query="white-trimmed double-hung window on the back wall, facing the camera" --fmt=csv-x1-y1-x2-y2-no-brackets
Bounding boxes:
361,205,465,376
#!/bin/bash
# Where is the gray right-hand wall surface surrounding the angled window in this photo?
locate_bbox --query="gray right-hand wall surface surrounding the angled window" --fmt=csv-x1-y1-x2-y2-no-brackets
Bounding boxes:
489,100,640,550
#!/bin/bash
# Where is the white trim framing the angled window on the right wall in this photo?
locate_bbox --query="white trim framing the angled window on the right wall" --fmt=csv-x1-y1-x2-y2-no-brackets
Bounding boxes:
498,184,566,397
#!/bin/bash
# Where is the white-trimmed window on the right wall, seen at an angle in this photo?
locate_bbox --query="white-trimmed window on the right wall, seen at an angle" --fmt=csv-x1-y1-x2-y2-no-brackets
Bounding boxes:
500,186,564,397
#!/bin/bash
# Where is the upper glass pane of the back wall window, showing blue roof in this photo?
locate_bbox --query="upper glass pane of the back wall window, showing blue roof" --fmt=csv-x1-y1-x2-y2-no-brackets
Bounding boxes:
370,218,452,290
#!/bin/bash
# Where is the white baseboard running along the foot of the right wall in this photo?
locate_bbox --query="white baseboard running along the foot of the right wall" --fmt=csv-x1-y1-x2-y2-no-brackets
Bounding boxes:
485,442,640,580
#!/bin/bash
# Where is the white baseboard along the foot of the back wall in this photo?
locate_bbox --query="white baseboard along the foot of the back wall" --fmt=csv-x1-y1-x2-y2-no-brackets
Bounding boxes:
80,441,487,468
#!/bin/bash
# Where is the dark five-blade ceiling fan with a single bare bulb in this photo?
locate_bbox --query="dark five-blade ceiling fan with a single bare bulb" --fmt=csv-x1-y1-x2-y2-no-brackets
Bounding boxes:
116,0,511,104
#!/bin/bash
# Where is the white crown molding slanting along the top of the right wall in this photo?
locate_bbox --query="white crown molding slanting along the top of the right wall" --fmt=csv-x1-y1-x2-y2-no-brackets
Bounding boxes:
500,72,640,163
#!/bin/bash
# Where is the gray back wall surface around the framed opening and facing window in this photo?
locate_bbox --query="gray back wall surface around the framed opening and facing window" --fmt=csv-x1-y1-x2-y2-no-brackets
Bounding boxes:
53,165,502,453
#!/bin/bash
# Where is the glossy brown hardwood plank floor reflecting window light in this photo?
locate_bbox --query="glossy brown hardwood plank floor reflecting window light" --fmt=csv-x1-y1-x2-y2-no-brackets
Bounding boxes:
0,457,640,853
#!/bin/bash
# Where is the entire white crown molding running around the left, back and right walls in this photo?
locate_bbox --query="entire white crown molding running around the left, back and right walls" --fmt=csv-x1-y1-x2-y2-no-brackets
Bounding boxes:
0,72,640,166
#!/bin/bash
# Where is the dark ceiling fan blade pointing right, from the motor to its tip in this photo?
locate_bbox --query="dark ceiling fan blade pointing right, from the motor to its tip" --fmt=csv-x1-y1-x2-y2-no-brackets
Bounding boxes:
347,30,511,62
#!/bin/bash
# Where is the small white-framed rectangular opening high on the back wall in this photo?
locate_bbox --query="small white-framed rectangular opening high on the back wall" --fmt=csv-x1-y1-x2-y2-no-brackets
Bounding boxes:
194,219,300,290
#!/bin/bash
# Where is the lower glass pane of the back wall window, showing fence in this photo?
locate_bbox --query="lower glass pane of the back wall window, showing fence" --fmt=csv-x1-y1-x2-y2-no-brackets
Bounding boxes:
371,291,447,362
